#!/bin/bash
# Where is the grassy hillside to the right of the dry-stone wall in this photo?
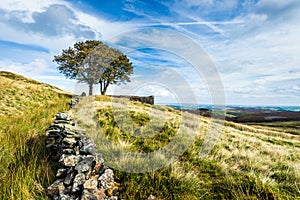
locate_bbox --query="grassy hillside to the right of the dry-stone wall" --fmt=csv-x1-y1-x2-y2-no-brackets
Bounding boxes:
74,97,300,200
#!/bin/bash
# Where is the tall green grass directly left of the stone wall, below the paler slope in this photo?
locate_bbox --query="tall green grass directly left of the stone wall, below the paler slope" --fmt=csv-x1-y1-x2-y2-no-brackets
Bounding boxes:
0,96,69,199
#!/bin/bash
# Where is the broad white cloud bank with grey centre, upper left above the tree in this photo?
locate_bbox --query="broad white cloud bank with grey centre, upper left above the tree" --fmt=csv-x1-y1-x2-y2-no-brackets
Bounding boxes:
0,0,136,52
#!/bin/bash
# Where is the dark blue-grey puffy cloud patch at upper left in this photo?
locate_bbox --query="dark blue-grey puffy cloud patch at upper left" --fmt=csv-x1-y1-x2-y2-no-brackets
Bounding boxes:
0,4,96,39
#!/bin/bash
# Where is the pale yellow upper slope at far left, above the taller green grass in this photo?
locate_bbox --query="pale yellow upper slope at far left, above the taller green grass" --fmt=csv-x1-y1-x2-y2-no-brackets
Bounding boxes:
0,71,71,116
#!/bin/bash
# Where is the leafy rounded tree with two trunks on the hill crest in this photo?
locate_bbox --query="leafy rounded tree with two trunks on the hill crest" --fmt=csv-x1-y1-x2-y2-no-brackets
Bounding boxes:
53,40,133,95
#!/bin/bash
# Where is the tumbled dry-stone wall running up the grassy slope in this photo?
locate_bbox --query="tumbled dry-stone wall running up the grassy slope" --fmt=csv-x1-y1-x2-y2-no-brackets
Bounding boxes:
46,113,118,200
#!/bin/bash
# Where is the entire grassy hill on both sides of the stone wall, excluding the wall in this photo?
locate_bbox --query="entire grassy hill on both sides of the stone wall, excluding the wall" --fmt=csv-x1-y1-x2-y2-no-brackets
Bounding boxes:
0,72,300,200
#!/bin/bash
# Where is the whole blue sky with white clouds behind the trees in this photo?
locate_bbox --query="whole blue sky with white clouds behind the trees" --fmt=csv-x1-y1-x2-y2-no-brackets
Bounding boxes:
0,0,300,106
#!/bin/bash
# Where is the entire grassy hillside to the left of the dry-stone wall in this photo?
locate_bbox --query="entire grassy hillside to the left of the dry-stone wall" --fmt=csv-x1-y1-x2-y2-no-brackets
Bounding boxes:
0,71,71,199
